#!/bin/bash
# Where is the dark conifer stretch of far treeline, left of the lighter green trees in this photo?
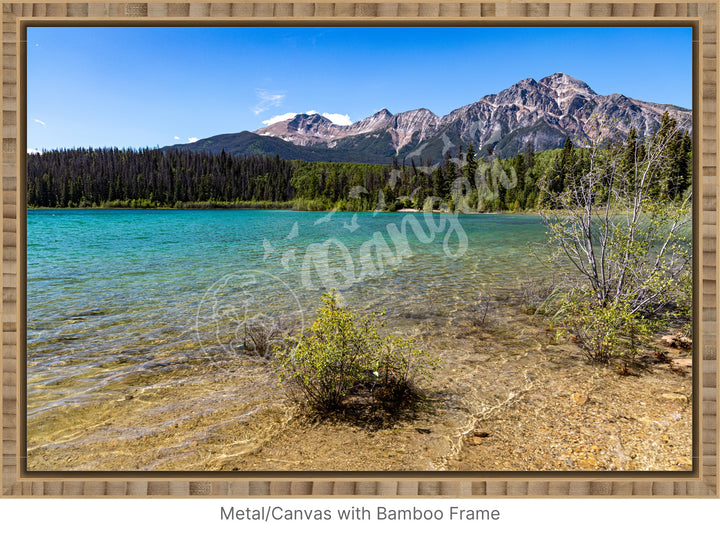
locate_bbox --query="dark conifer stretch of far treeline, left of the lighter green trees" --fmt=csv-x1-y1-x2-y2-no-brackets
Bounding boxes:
27,149,300,207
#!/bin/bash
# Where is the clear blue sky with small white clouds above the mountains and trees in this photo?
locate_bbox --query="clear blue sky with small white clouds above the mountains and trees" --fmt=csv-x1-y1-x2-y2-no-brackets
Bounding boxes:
27,27,692,153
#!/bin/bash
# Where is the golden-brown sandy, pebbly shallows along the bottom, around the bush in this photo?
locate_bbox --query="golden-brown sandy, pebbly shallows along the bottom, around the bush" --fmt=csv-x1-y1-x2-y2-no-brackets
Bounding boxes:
28,294,692,471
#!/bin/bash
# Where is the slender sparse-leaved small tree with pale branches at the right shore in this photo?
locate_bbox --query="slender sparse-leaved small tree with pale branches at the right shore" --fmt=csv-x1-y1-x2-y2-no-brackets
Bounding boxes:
541,115,691,363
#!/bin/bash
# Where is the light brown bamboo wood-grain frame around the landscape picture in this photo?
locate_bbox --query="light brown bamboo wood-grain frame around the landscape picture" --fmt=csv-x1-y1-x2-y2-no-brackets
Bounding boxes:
0,1,719,497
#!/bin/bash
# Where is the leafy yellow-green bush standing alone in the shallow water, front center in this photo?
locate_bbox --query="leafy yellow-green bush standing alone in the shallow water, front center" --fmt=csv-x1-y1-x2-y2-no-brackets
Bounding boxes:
276,292,438,412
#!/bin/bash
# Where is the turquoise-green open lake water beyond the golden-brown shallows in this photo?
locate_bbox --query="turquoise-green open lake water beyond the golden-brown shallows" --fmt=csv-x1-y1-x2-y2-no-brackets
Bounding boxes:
27,210,545,418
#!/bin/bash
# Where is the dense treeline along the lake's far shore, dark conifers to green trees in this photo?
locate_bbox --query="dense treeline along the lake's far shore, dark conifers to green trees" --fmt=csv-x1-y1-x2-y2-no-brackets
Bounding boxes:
27,116,692,211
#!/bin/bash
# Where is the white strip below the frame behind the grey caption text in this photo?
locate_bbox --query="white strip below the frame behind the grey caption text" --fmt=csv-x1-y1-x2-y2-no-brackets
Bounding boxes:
0,498,720,535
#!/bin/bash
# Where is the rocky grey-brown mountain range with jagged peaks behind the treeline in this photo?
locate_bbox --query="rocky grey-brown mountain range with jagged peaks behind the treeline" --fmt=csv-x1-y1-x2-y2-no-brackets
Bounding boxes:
169,73,692,163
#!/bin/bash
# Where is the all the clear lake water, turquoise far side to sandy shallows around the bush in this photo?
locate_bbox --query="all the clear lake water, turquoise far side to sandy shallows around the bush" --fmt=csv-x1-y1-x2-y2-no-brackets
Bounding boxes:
27,210,692,471
